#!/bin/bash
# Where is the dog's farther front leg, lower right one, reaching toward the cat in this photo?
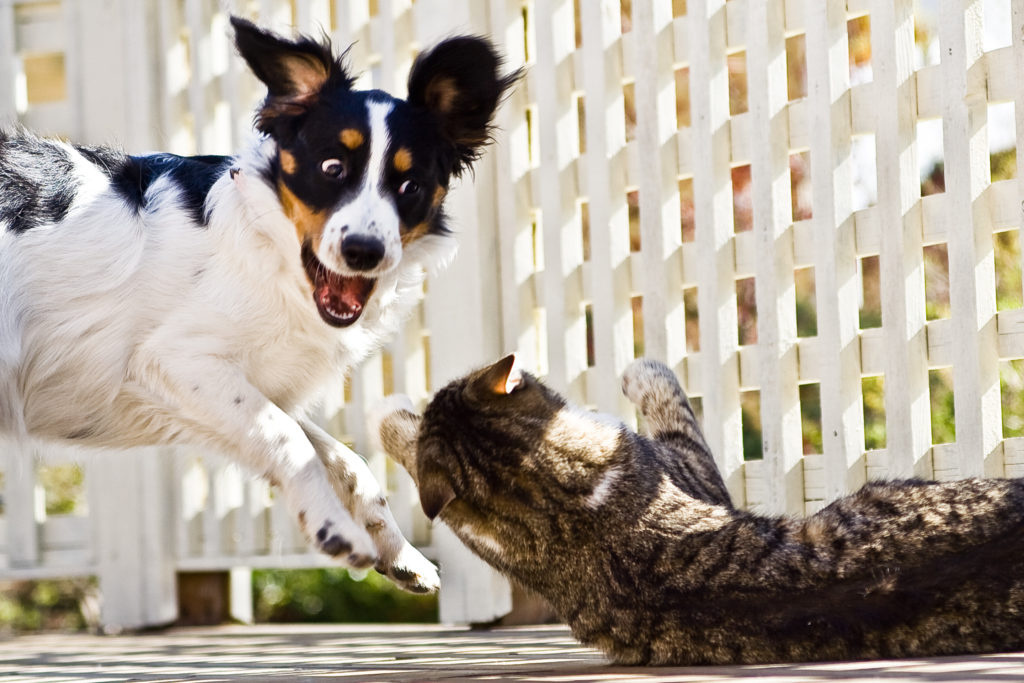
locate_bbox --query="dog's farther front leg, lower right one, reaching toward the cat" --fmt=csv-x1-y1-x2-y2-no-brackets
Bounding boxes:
299,420,439,593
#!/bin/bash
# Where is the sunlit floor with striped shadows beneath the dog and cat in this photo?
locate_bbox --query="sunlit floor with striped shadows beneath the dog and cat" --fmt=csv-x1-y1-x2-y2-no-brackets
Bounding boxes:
0,625,1024,683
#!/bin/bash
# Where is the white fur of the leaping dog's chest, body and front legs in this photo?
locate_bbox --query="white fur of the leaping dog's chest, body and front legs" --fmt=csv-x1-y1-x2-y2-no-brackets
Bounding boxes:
0,133,454,590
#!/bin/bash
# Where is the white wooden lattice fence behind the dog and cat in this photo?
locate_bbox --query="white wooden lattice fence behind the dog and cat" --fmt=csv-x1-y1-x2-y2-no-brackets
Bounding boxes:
0,0,1024,624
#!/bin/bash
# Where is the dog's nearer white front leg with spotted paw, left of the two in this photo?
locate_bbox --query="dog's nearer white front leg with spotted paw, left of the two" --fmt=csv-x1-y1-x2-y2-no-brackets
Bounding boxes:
161,357,378,568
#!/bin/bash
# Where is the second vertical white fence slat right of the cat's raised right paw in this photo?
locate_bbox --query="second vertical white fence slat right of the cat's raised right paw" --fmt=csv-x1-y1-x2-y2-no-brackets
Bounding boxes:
737,0,804,514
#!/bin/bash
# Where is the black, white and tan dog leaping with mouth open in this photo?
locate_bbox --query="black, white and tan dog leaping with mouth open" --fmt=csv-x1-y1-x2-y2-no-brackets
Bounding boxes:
0,18,515,592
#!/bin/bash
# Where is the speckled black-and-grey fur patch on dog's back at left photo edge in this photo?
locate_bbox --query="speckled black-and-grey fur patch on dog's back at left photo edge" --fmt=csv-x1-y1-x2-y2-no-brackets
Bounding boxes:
0,131,80,233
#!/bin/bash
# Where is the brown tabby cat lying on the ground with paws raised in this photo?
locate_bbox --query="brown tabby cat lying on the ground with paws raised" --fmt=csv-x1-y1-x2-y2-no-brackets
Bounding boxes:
377,356,1024,665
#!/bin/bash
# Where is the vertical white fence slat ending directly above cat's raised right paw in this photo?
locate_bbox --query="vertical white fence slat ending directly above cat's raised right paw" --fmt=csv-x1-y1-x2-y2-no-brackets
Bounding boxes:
632,2,684,372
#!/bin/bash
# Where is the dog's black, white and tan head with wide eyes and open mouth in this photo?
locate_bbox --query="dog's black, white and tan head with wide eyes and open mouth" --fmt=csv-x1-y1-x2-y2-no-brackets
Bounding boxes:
231,17,516,327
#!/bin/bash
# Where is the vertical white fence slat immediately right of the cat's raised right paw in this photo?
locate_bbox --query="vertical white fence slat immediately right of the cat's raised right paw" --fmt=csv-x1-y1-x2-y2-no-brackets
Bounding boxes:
688,0,744,505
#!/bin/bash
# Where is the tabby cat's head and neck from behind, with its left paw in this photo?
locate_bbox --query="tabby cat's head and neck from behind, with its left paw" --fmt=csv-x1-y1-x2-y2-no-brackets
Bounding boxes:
372,355,625,565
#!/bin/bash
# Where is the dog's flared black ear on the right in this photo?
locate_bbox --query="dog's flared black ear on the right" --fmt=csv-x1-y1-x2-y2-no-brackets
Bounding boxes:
409,36,521,176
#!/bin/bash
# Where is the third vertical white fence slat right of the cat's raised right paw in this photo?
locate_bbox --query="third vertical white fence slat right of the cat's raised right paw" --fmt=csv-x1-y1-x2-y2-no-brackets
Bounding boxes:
804,2,864,500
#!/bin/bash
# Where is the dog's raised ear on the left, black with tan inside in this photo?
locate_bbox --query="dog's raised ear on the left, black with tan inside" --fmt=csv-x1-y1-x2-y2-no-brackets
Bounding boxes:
231,16,354,135
